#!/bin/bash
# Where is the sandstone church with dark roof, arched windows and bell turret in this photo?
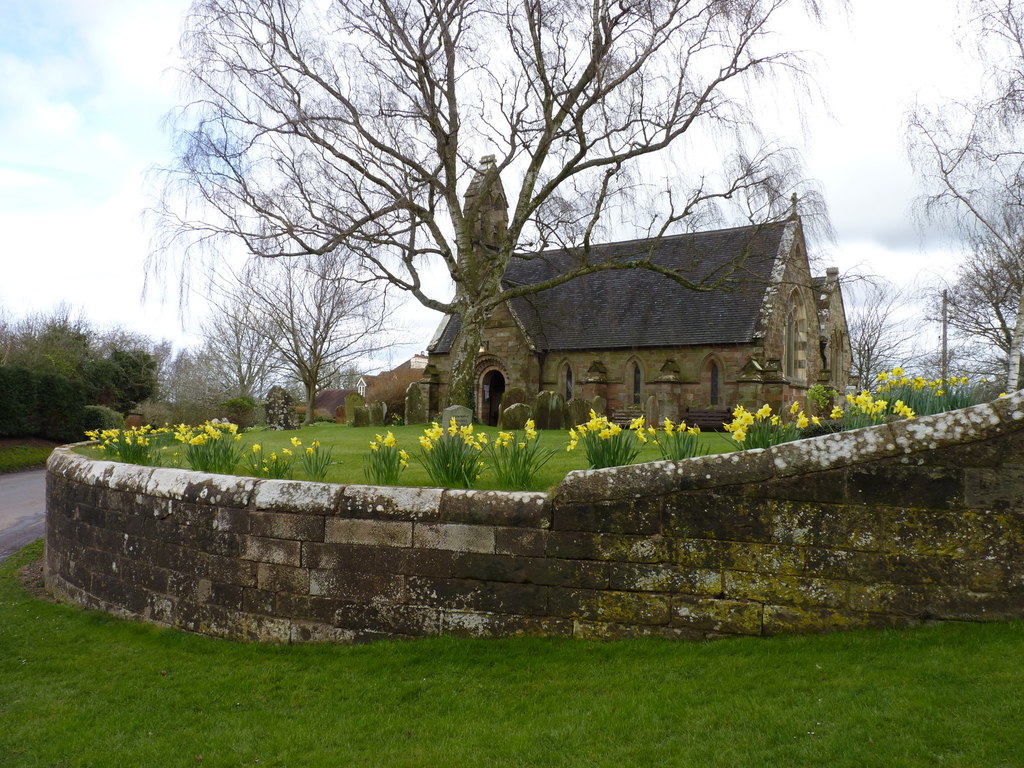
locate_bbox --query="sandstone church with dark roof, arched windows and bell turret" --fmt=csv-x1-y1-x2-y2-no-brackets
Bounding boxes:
423,158,850,425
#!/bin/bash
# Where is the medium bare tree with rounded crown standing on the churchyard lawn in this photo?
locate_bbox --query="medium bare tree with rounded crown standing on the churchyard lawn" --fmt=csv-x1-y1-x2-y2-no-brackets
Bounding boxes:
226,253,390,424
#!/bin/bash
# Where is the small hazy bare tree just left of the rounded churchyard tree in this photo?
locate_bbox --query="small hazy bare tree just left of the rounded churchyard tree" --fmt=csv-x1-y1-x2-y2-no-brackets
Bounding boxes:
200,290,282,399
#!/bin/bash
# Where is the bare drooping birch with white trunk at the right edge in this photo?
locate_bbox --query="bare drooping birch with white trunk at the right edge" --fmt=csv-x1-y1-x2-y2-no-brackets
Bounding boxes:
909,0,1024,389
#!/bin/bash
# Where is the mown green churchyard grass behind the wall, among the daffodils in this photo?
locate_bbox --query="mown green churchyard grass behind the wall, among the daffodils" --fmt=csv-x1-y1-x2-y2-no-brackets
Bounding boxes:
80,422,736,490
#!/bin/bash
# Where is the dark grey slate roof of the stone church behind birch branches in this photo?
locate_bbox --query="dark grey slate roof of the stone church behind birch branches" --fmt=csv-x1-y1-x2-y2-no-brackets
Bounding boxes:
431,221,793,354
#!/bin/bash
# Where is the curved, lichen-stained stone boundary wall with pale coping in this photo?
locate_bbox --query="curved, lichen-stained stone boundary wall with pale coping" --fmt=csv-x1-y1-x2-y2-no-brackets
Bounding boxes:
46,393,1024,642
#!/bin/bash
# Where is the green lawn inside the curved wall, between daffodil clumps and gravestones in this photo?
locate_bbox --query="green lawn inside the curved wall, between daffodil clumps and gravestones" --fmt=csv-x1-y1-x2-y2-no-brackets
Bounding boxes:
75,423,735,490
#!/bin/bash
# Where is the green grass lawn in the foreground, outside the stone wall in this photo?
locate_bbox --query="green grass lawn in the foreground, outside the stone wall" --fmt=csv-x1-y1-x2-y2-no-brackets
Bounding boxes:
0,544,1024,768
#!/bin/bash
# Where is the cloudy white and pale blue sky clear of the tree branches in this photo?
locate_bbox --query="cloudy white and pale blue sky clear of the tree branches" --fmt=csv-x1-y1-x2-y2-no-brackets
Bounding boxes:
0,0,973,372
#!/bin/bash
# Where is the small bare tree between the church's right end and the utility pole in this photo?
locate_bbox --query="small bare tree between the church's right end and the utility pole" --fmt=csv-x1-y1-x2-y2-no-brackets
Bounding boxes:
848,279,919,387
